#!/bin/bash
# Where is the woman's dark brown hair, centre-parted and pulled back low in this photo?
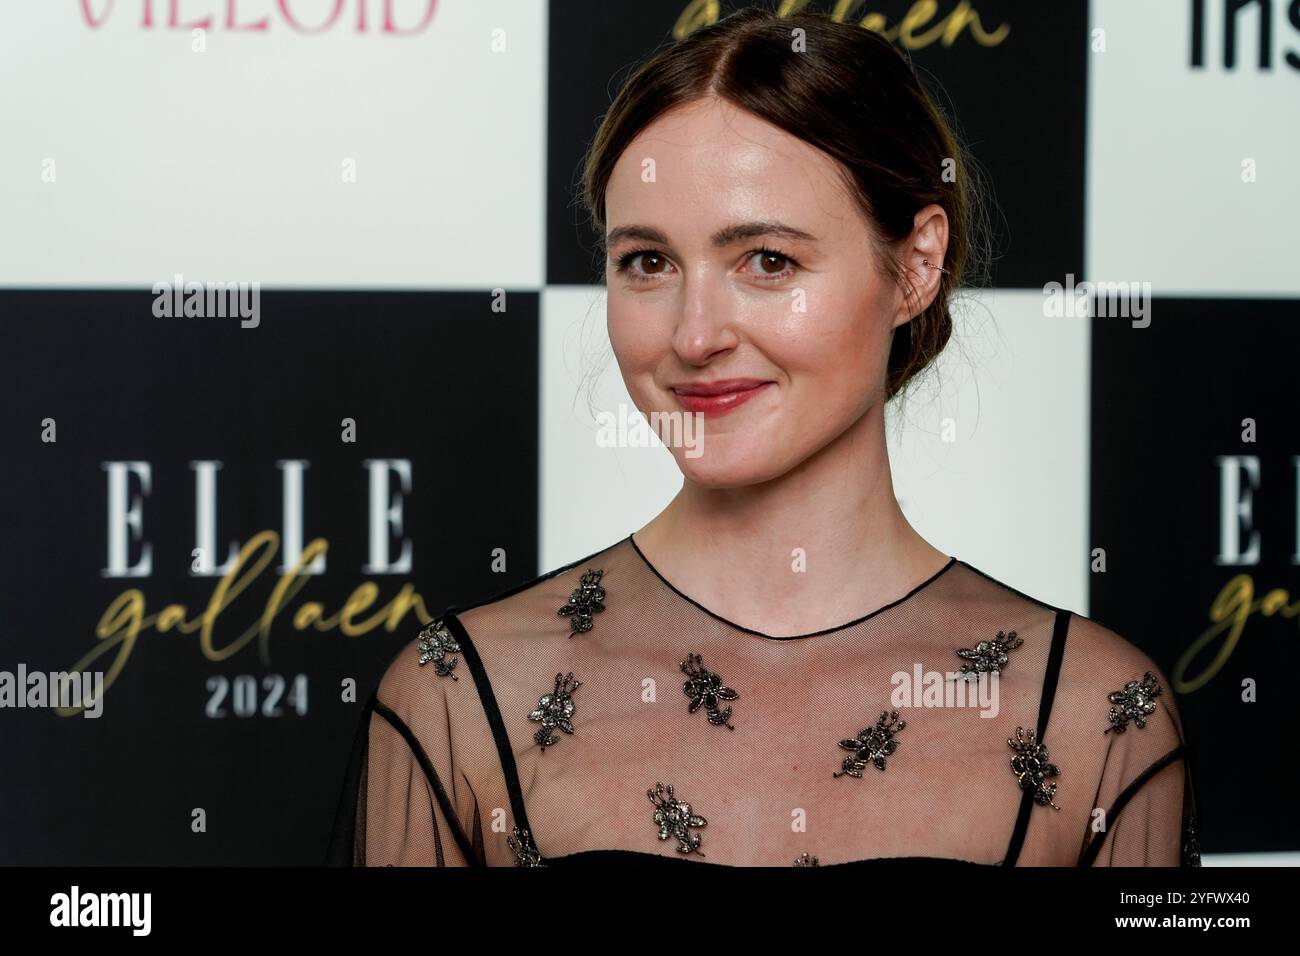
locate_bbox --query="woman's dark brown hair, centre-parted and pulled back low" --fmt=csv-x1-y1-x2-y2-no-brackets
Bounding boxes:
581,8,988,399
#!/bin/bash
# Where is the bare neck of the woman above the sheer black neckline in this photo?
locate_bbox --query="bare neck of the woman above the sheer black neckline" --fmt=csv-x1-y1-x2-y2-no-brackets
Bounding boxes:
636,405,948,636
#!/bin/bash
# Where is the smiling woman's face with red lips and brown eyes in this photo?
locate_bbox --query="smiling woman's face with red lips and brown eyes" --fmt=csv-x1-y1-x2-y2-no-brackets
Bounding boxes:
606,99,909,488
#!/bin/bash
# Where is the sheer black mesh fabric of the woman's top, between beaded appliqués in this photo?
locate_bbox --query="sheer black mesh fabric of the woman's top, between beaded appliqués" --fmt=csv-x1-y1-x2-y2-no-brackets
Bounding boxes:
330,537,1197,866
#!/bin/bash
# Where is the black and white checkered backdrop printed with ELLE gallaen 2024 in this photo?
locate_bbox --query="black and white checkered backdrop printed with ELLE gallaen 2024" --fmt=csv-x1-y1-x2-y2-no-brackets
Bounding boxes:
0,0,1300,864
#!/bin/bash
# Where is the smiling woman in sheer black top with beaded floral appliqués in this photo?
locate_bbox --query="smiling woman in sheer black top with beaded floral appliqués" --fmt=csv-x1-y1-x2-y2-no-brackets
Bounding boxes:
332,9,1199,866
